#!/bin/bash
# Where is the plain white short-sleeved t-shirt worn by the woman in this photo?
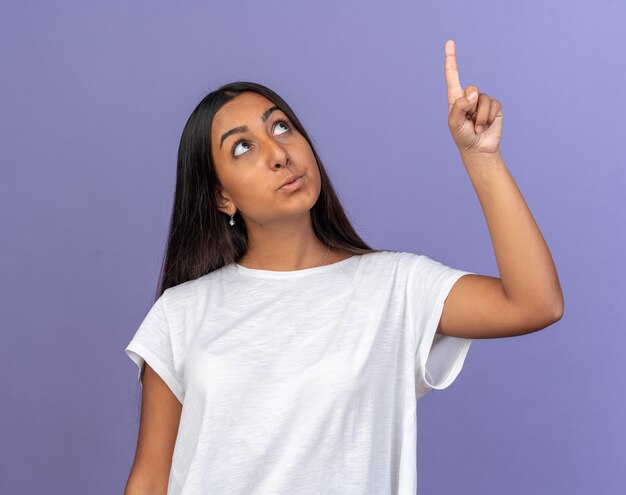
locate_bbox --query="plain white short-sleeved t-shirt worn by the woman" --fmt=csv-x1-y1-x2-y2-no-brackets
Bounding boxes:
125,251,474,495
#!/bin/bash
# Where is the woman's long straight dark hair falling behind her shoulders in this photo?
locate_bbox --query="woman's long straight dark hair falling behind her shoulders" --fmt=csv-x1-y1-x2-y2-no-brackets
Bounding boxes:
156,81,377,299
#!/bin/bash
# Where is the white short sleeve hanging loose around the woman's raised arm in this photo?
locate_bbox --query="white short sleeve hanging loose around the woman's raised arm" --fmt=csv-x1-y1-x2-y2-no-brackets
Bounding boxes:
407,255,475,399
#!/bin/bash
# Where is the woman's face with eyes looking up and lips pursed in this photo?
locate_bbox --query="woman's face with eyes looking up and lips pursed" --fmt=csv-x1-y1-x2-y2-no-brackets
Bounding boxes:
211,91,321,226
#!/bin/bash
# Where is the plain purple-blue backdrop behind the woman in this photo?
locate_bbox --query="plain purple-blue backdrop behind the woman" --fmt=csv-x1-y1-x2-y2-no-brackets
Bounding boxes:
0,0,626,495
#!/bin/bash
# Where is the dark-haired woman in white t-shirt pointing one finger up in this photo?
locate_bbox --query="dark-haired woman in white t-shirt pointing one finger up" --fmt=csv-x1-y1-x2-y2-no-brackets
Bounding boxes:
125,42,563,495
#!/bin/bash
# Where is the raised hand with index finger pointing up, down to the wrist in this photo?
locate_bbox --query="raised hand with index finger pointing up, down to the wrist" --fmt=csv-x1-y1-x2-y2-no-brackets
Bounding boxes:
445,40,502,156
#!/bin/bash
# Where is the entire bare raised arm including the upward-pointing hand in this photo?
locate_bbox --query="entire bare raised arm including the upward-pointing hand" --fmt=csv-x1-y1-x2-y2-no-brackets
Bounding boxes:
437,40,564,338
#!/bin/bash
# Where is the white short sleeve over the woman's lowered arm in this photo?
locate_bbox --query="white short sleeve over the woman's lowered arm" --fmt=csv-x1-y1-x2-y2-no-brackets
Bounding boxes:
125,291,184,403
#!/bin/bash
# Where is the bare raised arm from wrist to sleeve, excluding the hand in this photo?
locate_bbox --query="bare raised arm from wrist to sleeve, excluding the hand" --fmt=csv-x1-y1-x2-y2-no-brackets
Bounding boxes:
437,152,564,338
